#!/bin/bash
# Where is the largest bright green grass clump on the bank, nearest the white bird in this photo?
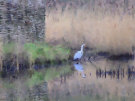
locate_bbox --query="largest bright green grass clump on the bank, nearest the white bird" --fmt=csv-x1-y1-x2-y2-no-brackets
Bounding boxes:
24,43,70,62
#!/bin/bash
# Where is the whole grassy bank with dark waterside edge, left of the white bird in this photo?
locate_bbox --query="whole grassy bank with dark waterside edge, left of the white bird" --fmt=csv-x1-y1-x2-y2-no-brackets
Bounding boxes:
0,42,70,70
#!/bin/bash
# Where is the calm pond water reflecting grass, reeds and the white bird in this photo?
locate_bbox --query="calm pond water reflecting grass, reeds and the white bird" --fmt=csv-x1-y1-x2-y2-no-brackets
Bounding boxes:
0,59,135,101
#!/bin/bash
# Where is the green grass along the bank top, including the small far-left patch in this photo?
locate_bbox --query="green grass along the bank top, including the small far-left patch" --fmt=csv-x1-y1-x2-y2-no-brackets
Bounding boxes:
2,42,70,64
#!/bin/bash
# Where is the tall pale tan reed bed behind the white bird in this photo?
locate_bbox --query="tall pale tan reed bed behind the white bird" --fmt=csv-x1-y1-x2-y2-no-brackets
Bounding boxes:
46,9,135,54
